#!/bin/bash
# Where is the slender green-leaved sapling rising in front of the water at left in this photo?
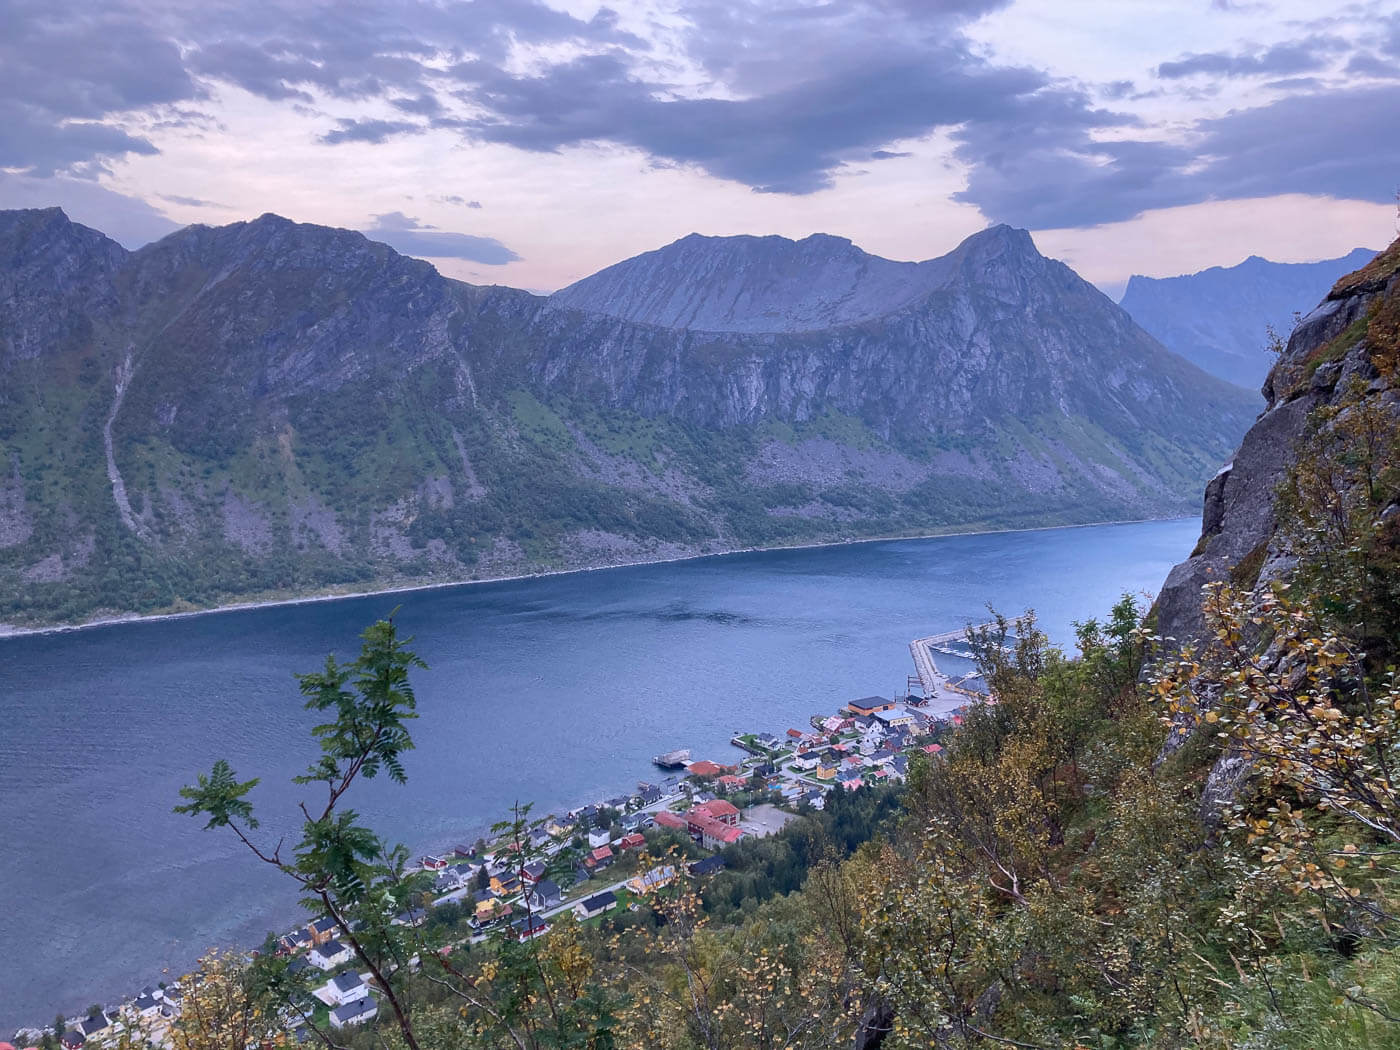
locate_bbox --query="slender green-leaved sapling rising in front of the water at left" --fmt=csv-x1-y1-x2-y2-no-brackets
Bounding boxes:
175,615,427,1050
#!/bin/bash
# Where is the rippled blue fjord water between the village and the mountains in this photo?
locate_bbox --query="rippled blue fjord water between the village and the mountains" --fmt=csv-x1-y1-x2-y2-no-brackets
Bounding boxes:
0,521,1198,1033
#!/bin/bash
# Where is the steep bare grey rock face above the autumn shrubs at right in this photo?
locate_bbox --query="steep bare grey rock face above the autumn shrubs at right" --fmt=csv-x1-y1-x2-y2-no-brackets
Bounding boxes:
1156,241,1400,643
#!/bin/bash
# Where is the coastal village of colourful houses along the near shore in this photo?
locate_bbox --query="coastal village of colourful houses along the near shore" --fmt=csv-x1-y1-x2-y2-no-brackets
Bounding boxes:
13,631,995,1050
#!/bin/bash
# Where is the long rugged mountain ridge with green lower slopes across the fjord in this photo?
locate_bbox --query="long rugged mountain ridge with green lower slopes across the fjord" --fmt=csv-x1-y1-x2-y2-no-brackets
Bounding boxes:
0,209,1253,623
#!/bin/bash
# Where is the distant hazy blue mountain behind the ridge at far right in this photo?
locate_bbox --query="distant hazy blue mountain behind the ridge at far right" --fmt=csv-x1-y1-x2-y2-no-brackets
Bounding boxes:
1119,248,1376,389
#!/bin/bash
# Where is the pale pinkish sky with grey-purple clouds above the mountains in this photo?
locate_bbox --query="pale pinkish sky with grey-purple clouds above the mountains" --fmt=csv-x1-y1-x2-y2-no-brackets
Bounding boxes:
0,0,1400,297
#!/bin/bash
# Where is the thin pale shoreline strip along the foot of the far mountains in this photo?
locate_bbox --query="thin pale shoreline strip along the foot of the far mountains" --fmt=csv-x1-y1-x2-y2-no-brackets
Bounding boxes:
0,515,1191,644
